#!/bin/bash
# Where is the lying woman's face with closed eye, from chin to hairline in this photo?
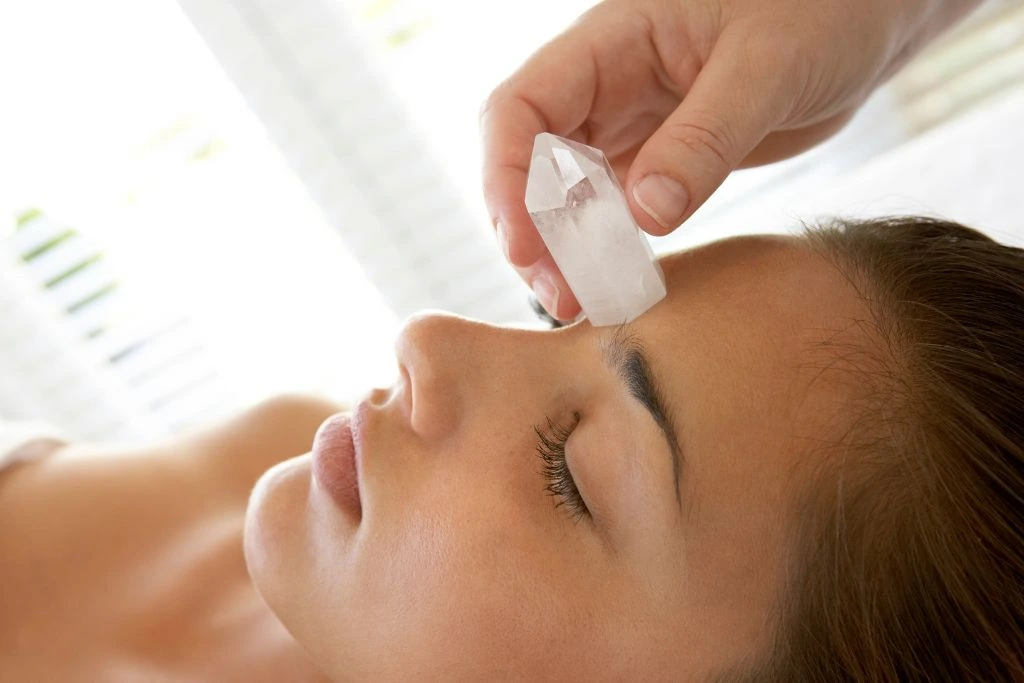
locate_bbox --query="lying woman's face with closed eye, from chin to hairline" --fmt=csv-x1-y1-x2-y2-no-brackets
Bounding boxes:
246,237,866,681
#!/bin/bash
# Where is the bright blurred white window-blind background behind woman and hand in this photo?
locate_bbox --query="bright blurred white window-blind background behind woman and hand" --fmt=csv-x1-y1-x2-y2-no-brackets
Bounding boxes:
0,0,1024,439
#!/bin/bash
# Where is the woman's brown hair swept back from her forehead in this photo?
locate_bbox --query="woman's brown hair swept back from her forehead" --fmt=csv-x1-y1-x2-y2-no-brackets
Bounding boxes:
745,217,1024,683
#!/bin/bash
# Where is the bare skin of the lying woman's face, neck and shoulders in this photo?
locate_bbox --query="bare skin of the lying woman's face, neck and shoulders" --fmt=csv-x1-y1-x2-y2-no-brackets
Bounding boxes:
0,237,867,683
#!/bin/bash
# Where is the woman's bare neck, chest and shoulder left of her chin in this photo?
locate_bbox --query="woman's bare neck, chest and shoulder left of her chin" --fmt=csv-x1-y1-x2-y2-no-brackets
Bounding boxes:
0,395,342,683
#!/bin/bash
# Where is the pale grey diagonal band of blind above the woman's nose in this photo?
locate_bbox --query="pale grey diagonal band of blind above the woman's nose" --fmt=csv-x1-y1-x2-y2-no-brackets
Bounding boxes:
179,0,531,322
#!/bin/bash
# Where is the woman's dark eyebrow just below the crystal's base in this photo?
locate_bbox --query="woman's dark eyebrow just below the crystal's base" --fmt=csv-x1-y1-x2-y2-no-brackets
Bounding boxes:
604,325,683,507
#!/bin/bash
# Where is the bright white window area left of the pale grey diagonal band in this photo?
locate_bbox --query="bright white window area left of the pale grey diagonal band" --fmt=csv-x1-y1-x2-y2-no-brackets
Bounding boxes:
0,0,411,438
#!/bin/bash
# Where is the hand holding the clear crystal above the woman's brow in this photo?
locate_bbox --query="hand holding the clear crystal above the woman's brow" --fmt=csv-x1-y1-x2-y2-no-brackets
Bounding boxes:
480,0,980,319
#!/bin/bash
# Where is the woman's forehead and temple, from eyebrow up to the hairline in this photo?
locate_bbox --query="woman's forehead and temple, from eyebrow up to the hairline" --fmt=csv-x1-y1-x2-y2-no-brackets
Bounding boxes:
635,236,870,557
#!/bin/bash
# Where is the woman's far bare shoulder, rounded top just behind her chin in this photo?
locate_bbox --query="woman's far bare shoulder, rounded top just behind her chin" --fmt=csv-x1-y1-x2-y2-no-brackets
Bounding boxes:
182,394,346,496
